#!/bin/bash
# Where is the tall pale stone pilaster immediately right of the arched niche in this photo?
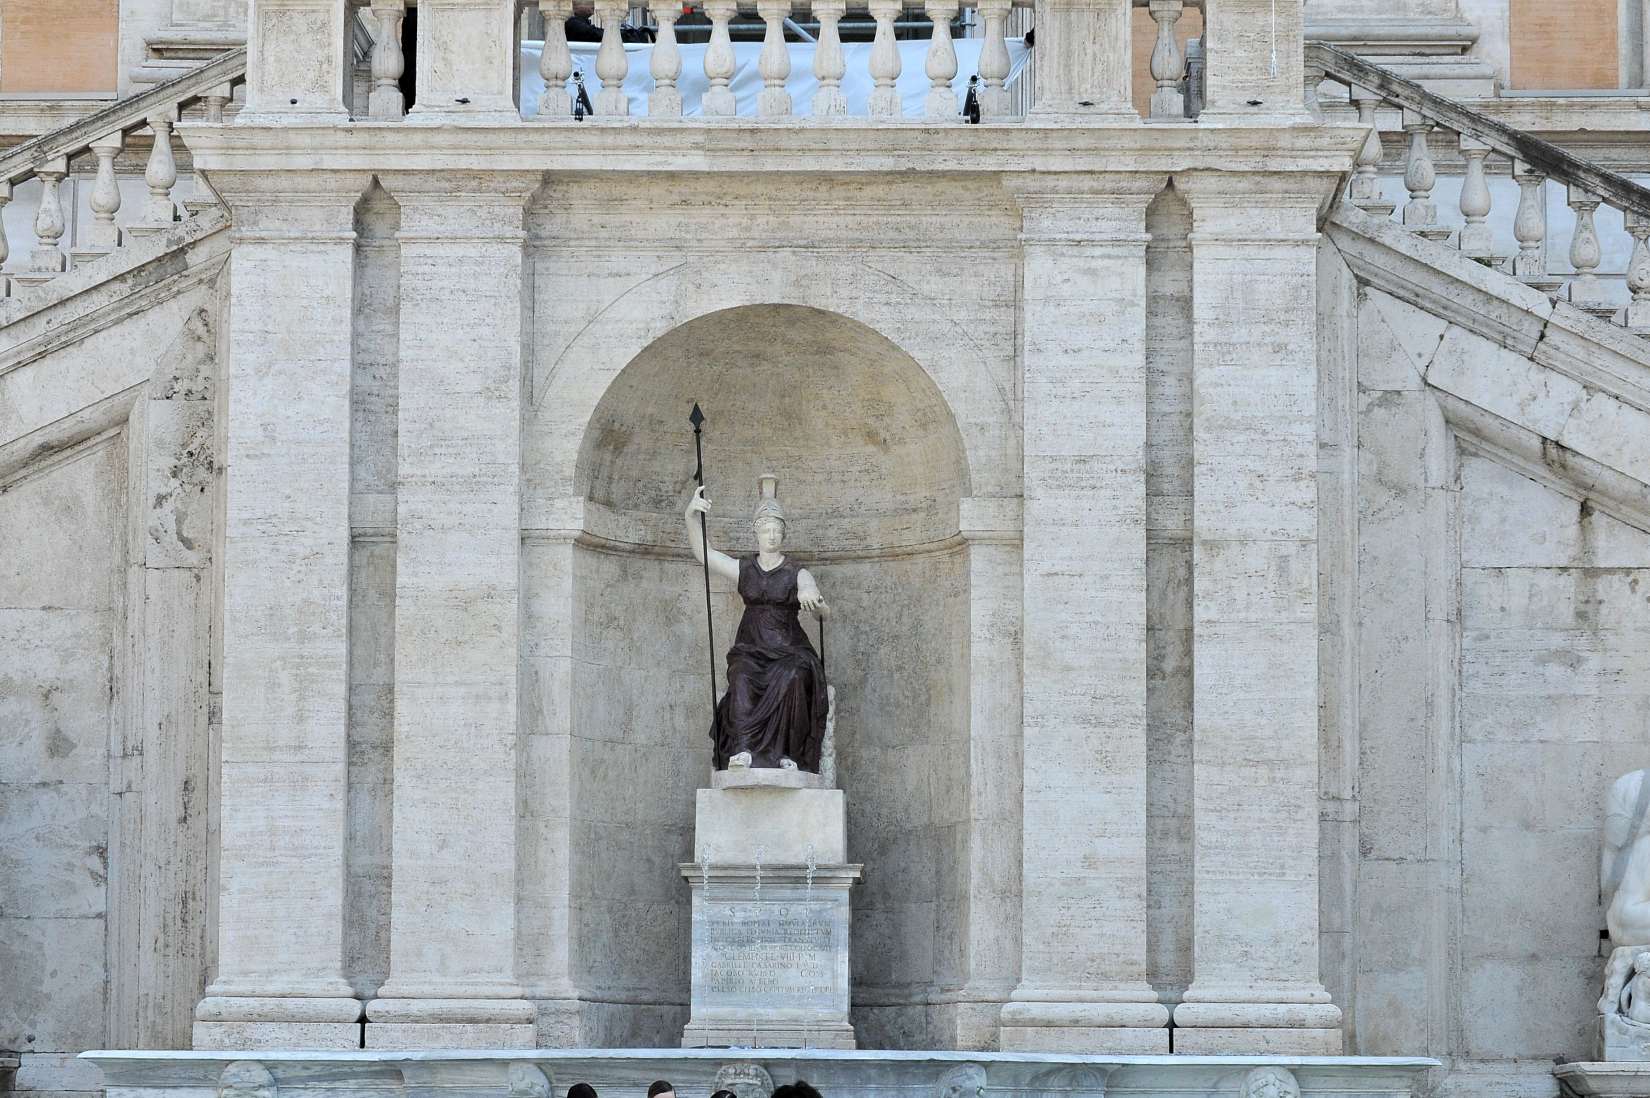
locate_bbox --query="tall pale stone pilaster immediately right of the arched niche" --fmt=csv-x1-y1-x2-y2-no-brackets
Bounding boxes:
1002,175,1168,1053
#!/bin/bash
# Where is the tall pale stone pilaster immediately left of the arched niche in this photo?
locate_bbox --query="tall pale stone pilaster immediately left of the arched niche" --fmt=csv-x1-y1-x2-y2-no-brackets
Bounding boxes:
366,173,538,1048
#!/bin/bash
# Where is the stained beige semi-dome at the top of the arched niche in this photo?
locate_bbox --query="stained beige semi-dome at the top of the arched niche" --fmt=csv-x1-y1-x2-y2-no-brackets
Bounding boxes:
578,305,967,553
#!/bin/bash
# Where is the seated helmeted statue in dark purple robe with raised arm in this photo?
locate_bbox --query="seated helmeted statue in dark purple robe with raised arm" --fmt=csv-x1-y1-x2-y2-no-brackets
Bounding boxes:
683,477,830,774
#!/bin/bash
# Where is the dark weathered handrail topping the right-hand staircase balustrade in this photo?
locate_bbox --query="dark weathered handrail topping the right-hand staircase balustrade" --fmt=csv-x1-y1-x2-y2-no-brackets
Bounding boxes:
1307,41,1650,215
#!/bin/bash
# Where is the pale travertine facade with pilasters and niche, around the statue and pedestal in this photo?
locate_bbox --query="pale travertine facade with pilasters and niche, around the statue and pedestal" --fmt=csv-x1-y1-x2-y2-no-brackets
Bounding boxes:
0,0,1650,1095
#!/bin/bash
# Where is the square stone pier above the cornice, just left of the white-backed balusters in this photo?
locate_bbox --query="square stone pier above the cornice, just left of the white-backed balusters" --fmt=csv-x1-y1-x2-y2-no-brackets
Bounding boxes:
408,0,521,122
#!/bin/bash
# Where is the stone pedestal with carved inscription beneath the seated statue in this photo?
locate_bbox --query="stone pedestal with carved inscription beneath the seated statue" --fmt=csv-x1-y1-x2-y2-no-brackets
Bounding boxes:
681,769,860,1048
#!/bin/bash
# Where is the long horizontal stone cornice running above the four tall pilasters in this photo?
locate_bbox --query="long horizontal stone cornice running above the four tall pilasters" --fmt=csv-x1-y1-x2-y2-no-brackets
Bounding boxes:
180,119,1365,176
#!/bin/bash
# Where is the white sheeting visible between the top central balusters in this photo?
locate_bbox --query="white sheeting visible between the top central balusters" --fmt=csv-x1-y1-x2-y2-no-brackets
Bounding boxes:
521,38,1026,119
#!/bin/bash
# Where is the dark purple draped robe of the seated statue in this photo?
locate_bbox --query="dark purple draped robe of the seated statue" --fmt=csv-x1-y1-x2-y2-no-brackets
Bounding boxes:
711,556,827,773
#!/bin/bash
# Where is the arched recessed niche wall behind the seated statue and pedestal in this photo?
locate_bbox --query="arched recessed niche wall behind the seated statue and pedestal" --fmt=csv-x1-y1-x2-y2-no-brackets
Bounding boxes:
571,305,969,1045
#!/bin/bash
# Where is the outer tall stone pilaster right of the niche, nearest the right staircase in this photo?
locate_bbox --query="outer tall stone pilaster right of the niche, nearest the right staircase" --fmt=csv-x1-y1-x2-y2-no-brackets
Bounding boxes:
1175,172,1341,1055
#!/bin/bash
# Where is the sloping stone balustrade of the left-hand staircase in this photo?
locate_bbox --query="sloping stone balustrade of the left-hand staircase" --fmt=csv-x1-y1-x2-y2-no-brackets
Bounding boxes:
0,50,246,296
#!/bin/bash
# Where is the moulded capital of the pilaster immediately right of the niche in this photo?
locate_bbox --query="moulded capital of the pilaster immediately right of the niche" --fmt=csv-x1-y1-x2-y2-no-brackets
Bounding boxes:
1005,172,1168,248
